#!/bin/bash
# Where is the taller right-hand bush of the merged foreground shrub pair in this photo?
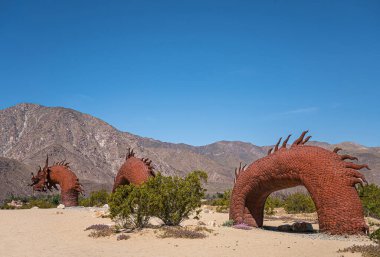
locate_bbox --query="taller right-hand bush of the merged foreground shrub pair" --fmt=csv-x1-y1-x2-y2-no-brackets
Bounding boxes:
146,171,207,226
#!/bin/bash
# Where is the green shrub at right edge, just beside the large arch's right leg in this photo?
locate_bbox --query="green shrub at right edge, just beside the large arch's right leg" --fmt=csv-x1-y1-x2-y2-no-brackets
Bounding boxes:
358,184,380,218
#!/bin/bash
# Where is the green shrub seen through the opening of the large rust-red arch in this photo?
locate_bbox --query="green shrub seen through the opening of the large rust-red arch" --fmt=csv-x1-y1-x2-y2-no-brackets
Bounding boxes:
284,193,316,213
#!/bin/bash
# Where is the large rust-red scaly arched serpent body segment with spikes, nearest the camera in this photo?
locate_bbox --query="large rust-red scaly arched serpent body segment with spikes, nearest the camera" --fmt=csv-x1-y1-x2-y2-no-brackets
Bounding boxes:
230,131,369,234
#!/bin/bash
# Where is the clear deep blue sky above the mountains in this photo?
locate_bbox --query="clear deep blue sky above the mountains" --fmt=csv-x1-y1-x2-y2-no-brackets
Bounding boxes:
0,0,380,146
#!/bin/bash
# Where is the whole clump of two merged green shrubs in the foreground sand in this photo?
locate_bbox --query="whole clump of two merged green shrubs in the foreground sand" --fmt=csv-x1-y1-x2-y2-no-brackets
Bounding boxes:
108,171,207,229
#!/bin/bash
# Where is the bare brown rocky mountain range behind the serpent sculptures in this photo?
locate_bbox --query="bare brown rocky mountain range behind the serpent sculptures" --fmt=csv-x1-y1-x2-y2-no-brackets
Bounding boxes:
0,104,380,198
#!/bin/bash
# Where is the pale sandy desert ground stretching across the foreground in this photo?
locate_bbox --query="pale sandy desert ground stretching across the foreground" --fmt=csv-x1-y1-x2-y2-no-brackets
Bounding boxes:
0,208,370,257
